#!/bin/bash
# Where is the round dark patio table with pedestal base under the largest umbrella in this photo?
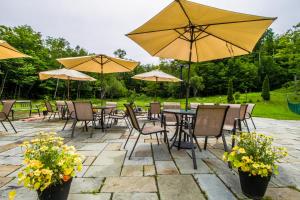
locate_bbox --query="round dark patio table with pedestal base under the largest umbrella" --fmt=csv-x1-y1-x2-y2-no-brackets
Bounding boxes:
162,109,196,150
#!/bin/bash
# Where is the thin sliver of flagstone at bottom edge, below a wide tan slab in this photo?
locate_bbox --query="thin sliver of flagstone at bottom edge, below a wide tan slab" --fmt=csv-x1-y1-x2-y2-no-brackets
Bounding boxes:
112,193,158,200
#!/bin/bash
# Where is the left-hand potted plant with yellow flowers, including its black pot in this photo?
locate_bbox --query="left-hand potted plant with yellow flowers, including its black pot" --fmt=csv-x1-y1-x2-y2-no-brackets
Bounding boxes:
18,133,82,200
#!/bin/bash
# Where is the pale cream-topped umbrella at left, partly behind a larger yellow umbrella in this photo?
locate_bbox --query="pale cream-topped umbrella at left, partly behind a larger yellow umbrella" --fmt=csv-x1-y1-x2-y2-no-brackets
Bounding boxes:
39,69,96,99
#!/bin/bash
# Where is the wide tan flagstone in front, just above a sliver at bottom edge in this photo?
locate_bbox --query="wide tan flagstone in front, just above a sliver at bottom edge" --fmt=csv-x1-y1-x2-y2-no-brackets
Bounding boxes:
101,177,157,193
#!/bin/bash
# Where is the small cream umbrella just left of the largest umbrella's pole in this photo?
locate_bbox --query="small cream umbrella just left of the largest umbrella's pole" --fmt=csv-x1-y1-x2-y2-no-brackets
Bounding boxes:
132,70,182,98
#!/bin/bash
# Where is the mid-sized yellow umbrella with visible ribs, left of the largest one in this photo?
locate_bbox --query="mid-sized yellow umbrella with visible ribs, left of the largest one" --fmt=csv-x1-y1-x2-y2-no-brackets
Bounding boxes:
57,54,139,98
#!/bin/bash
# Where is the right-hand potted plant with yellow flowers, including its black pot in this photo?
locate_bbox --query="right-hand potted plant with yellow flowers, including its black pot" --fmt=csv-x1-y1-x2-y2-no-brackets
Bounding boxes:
223,133,287,199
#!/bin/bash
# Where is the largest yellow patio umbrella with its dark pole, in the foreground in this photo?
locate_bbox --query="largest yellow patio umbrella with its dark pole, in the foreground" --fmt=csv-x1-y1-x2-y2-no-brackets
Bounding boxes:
127,0,276,108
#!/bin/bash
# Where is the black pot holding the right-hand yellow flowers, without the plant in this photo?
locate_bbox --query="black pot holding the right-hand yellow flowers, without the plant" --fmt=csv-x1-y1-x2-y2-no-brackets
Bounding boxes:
239,170,271,199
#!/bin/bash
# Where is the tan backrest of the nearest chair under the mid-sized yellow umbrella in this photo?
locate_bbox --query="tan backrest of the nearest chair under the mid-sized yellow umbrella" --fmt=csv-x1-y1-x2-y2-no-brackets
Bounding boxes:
73,102,94,121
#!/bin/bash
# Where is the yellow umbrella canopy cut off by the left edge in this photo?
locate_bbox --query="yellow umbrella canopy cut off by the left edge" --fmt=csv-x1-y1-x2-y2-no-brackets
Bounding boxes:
0,40,30,60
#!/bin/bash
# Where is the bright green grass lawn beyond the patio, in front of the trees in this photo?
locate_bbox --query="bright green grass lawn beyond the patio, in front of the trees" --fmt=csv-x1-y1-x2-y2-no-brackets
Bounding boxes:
0,89,300,120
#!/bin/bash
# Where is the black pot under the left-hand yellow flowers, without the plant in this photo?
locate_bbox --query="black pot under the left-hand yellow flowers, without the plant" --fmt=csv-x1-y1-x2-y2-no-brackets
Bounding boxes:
37,179,72,200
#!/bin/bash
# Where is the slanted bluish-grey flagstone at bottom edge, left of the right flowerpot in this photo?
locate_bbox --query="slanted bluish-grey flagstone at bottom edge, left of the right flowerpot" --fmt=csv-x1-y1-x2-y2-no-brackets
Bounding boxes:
194,174,236,200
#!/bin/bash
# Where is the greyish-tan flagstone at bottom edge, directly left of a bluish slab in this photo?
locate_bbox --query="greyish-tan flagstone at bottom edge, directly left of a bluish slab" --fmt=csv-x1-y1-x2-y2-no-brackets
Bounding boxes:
157,175,205,200
